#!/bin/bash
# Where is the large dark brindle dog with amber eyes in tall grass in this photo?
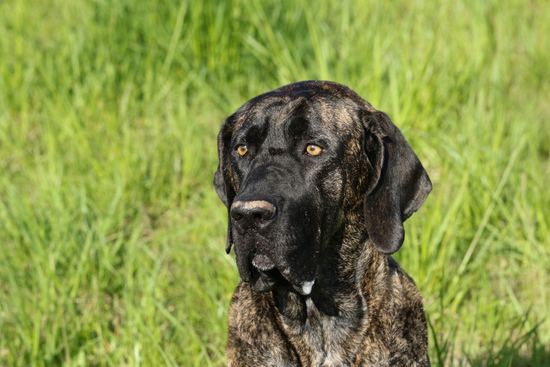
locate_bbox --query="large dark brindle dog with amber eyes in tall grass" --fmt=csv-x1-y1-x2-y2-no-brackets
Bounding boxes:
214,81,432,367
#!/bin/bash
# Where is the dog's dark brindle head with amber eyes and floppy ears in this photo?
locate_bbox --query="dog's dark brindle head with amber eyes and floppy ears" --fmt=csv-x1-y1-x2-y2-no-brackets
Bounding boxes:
214,81,431,295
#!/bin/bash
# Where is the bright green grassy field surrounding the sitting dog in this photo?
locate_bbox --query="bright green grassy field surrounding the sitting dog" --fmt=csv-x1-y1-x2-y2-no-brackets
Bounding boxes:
0,0,550,366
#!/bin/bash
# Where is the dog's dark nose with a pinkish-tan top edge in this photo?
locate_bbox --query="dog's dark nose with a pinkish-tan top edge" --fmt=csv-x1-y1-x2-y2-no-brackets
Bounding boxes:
230,200,277,229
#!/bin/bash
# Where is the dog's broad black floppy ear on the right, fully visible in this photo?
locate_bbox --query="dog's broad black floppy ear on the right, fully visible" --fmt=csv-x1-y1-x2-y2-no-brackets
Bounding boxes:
361,110,432,255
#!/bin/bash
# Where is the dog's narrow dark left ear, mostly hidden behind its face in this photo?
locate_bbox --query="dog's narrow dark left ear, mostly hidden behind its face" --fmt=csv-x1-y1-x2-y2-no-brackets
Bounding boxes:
214,115,235,253
